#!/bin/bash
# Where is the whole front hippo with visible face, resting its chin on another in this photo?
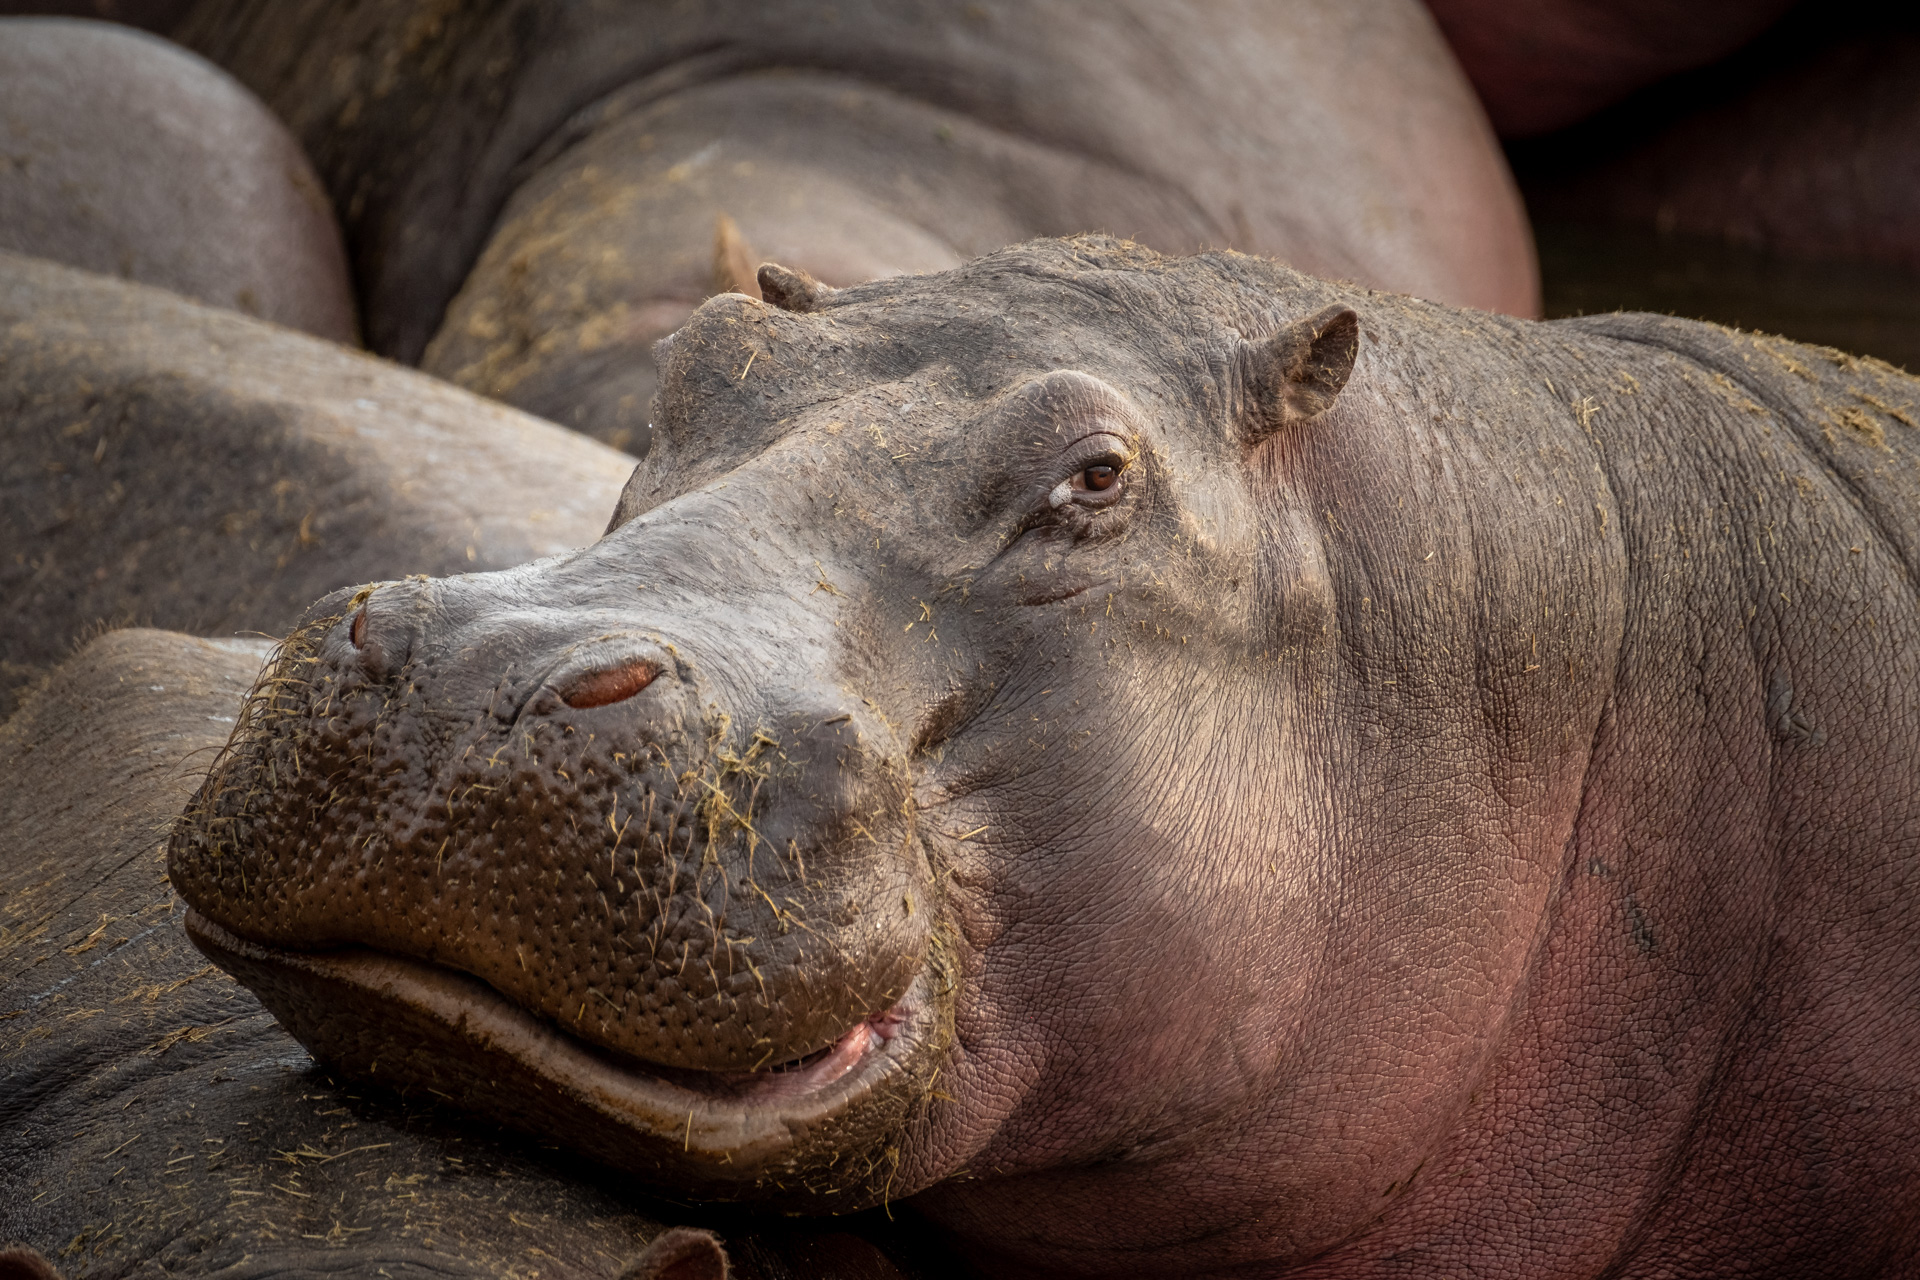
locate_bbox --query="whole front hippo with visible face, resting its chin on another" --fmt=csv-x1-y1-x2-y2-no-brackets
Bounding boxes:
169,238,1920,1280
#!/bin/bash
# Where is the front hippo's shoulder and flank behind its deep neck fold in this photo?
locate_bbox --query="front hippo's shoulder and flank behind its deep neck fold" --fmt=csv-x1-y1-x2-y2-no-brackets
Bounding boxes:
1327,317,1920,1274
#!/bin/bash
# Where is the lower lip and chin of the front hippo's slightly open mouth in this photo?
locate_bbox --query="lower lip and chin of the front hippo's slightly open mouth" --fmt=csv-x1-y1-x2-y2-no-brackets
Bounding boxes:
186,910,948,1211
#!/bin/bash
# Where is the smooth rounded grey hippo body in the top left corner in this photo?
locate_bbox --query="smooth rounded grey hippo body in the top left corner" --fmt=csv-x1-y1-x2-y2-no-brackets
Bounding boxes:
0,17,355,344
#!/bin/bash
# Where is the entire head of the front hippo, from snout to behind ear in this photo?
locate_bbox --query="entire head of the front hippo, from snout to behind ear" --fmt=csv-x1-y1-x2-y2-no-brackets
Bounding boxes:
169,240,1612,1274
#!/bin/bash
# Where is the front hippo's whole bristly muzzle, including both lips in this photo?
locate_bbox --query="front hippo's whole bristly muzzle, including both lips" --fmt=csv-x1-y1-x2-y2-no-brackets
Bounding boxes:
169,616,952,1203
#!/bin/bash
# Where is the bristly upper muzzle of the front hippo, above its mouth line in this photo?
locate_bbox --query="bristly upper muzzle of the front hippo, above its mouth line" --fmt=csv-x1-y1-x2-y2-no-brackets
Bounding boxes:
169,576,931,1092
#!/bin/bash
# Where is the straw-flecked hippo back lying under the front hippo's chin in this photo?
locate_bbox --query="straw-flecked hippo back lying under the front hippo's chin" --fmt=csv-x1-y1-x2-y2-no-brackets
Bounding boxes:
0,631,944,1280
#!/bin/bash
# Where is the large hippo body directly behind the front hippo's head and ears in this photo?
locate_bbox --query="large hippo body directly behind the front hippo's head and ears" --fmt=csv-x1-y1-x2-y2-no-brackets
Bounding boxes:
177,0,1538,453
